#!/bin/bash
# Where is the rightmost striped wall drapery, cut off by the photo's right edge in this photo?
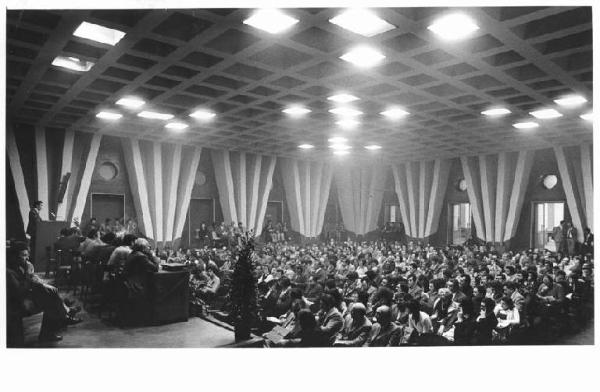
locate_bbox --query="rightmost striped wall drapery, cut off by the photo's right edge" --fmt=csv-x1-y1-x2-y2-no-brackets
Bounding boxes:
554,144,594,241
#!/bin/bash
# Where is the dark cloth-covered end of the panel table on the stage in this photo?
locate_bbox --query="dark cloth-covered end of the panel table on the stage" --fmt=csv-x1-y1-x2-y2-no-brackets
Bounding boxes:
150,270,190,324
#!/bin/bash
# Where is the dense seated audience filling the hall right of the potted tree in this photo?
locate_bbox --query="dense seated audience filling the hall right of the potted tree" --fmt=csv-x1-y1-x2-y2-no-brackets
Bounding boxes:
217,236,594,347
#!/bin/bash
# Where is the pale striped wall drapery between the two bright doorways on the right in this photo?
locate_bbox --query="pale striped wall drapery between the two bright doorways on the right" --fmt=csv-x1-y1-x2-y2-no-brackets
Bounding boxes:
460,151,535,243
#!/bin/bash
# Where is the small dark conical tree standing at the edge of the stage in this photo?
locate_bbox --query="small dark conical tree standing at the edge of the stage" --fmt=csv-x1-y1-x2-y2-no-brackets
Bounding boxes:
229,235,258,342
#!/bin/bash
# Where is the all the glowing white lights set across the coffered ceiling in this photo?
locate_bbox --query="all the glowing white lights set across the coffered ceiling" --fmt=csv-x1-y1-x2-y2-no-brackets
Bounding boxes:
52,9,593,155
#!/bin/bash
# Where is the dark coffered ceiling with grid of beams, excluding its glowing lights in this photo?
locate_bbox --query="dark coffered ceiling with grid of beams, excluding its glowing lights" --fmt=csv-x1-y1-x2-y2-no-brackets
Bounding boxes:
6,7,592,161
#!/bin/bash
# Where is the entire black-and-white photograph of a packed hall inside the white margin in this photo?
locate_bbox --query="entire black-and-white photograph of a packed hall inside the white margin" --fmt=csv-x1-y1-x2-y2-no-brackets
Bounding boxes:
2,2,598,388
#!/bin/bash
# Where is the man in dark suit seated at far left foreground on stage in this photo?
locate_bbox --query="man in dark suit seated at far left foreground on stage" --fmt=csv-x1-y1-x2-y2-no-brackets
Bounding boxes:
6,242,81,342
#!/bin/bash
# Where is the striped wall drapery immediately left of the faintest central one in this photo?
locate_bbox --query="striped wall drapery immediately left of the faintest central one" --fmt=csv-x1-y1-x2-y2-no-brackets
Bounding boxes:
279,159,333,238
